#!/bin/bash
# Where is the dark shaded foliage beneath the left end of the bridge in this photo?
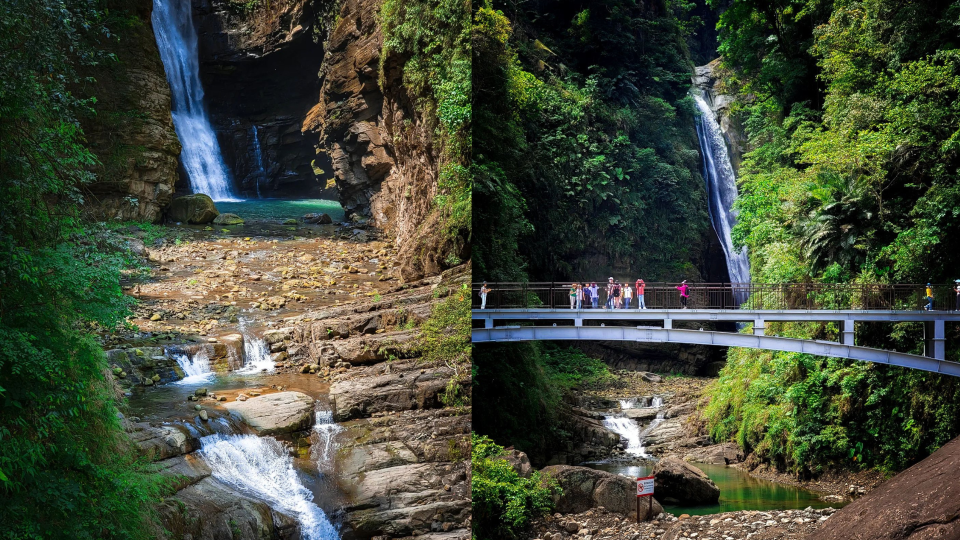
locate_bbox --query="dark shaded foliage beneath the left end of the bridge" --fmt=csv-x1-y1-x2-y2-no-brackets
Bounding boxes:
473,342,613,464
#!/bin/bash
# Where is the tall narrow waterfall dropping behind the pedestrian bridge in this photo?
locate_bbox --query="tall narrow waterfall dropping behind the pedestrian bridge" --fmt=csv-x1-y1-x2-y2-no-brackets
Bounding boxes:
693,93,750,292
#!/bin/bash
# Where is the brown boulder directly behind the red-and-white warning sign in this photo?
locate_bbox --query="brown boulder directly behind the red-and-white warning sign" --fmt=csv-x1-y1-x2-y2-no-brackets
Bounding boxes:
541,465,663,520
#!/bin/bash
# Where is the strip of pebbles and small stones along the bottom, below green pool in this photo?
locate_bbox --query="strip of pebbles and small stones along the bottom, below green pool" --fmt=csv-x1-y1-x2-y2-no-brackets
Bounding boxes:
528,508,835,540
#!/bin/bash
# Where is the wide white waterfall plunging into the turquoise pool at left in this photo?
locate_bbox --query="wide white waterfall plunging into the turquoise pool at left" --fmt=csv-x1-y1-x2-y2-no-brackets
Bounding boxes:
150,0,239,201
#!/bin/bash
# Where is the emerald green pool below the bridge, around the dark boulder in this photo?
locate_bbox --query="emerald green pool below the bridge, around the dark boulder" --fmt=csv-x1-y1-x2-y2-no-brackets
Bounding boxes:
584,462,844,516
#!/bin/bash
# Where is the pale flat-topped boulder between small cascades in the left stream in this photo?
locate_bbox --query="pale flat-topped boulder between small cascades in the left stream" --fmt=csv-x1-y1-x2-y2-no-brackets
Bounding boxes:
223,392,313,435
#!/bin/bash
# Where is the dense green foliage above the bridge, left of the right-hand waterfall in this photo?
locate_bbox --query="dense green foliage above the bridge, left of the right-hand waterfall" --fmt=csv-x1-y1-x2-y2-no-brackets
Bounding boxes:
473,0,710,281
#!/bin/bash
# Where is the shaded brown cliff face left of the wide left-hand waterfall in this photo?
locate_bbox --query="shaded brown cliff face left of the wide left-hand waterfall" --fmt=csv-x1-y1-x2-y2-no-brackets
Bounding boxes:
83,0,180,222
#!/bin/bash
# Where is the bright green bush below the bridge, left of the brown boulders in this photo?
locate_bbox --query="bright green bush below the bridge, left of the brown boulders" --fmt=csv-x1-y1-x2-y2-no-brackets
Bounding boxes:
470,433,560,540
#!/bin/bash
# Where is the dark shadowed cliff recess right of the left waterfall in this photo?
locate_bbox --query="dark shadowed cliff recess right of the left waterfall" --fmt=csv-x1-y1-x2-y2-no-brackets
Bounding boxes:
193,0,336,198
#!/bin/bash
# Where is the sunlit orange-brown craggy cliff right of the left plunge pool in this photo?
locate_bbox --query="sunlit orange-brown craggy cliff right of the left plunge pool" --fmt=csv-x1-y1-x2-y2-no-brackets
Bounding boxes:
303,0,454,280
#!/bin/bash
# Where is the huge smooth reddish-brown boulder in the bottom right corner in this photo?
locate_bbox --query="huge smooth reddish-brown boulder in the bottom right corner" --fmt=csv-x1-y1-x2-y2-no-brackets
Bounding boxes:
808,438,960,540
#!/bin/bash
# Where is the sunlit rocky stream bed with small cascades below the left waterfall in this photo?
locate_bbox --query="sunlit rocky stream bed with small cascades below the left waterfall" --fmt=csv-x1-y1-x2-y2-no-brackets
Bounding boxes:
104,215,471,540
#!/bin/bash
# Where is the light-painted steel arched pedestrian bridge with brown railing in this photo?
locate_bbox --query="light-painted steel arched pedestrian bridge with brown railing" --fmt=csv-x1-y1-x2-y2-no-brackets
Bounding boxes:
472,284,960,377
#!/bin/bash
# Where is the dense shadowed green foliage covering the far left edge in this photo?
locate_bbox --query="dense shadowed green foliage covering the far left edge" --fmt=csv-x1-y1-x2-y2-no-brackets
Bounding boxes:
0,0,158,539
